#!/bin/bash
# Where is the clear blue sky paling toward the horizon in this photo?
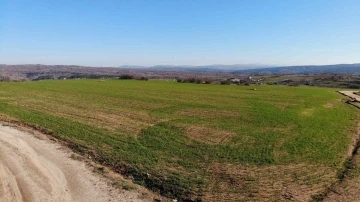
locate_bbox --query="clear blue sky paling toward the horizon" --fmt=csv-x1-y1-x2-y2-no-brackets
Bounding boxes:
0,0,360,66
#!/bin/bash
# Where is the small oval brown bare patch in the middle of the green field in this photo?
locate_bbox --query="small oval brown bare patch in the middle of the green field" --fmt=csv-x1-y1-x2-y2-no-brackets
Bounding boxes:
186,126,233,144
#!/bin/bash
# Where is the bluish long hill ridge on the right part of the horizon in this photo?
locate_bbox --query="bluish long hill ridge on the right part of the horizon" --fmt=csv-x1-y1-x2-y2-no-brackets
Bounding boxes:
232,63,360,74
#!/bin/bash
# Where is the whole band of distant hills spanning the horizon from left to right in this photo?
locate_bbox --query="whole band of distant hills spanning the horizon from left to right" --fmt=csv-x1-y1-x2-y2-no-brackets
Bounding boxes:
0,63,360,81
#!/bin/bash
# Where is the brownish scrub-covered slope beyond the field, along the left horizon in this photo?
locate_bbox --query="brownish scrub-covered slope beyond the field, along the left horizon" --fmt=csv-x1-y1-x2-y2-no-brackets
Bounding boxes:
0,64,233,81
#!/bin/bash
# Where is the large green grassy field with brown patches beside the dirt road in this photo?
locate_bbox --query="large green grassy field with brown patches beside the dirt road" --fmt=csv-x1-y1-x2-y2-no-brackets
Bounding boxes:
0,80,359,201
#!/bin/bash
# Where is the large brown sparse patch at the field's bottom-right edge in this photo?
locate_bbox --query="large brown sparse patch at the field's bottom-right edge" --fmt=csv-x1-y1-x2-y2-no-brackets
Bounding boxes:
204,163,337,201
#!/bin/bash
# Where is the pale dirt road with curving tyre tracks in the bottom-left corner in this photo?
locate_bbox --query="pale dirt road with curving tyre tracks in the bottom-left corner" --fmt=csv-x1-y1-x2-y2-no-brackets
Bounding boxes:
0,124,148,202
